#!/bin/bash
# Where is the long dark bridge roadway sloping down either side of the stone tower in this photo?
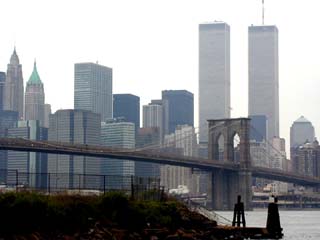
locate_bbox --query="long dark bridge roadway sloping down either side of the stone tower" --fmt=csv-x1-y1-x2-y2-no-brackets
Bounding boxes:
0,138,320,187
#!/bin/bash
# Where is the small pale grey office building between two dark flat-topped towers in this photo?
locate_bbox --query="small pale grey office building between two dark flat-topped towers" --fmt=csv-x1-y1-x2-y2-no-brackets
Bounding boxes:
142,103,164,142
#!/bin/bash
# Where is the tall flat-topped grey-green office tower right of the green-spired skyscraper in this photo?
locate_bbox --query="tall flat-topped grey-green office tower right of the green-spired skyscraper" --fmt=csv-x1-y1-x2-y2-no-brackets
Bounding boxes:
74,63,113,121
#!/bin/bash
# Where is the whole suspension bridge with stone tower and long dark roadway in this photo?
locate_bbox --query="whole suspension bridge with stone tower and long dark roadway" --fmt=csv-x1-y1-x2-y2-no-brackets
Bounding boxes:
0,118,320,209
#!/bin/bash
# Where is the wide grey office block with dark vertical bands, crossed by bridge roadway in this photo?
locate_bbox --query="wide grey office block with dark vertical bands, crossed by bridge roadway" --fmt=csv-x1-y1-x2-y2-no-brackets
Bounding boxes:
48,109,101,189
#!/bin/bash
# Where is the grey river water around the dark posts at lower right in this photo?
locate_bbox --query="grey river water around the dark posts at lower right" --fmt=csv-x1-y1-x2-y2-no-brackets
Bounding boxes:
217,209,320,240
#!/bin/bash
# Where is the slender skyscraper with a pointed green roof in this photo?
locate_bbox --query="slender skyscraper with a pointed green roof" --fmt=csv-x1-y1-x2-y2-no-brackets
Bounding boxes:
25,62,45,126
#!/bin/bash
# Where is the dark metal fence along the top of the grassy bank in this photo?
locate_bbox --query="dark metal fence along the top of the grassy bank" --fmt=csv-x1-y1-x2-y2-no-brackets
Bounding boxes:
0,169,163,200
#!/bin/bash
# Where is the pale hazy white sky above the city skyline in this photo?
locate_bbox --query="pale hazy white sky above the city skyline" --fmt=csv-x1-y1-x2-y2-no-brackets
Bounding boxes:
0,0,320,152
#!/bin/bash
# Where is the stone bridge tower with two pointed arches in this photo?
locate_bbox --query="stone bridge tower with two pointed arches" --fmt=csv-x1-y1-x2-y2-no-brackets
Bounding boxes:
208,118,252,210
